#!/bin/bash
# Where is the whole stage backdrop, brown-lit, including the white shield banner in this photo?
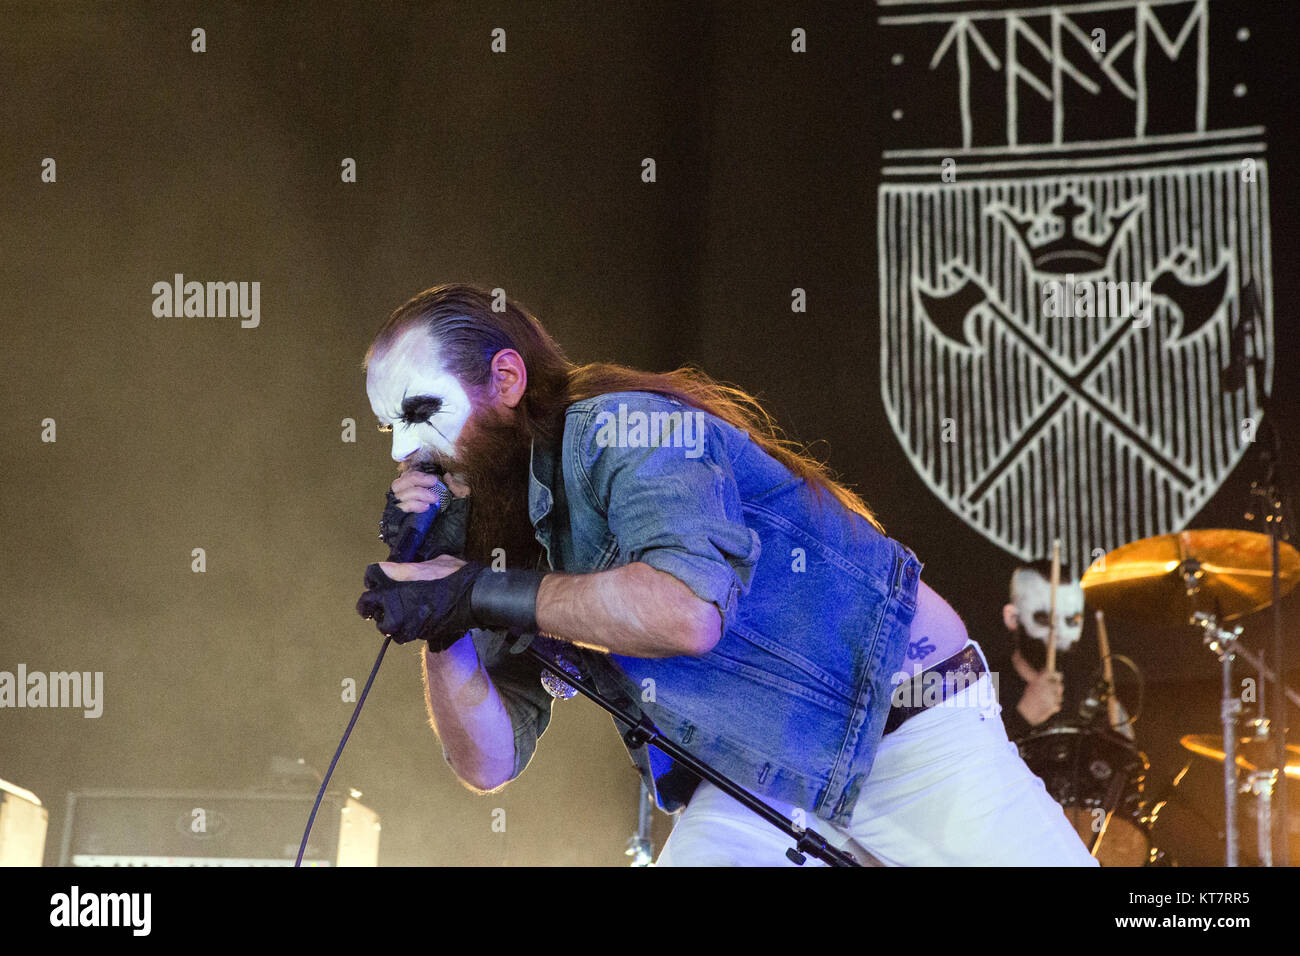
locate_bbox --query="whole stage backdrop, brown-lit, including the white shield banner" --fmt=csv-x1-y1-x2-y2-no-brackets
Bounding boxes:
0,0,1300,865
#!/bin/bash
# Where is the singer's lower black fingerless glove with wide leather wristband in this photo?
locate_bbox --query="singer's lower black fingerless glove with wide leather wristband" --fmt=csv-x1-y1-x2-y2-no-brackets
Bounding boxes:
356,562,546,653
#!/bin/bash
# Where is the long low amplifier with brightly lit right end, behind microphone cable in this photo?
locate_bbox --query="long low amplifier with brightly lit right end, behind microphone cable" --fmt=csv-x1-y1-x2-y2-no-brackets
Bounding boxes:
59,790,380,866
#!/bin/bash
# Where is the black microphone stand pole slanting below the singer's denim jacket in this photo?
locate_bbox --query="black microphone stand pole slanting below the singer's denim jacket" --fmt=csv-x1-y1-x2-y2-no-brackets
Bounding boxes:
520,643,862,866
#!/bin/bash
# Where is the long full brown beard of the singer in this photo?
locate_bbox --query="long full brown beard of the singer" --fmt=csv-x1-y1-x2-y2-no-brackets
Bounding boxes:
439,407,541,568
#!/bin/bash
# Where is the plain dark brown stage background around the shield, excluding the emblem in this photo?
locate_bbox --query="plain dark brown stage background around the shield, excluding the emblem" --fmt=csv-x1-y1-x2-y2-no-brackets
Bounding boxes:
0,1,1300,865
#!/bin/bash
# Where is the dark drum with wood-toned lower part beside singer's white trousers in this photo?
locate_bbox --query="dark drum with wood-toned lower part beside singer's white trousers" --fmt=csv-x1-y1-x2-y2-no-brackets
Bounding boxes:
1015,726,1160,866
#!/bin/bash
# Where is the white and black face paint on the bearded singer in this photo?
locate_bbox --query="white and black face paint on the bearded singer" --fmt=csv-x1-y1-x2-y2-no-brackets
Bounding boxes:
365,328,473,462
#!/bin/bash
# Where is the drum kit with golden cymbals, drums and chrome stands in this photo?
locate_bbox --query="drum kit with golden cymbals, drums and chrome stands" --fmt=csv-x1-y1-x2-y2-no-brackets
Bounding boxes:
1017,529,1300,866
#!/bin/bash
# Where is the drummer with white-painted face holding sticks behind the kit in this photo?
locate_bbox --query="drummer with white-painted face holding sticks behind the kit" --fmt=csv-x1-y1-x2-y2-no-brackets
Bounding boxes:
991,561,1134,740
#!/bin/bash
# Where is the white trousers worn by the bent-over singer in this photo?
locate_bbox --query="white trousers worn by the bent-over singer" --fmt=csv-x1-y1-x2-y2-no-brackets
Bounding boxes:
655,643,1097,866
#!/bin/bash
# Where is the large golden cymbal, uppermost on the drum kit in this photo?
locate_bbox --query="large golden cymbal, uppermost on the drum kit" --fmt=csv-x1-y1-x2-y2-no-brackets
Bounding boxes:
1083,528,1300,627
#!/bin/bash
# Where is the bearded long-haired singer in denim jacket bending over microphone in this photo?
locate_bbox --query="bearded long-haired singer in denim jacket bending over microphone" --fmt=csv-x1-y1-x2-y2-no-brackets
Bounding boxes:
358,285,1096,866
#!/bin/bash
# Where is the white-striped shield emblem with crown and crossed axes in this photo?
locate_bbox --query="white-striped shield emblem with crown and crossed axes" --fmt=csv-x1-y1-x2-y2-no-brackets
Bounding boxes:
878,4,1273,572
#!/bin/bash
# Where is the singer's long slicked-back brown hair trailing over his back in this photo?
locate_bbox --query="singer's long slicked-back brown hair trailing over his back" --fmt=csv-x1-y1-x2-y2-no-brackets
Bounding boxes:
361,282,883,531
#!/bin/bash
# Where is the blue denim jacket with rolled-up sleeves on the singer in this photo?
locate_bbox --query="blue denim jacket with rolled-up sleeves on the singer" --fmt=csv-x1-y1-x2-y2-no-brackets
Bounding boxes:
473,392,922,823
